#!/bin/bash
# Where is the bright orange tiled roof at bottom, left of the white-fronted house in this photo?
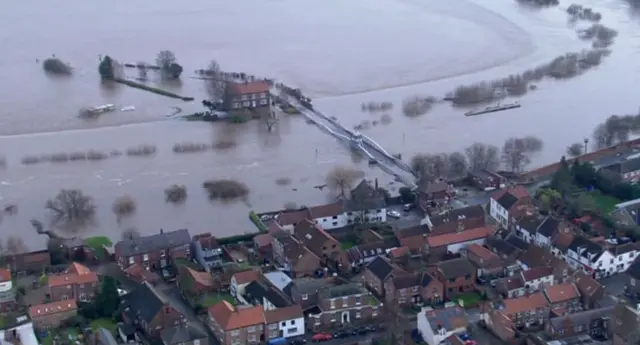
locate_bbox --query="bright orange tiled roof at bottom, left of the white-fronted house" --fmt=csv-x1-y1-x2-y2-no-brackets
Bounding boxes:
208,301,265,331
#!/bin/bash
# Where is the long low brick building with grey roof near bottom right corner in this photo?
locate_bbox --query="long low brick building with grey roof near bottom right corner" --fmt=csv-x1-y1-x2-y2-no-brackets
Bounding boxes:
545,306,614,339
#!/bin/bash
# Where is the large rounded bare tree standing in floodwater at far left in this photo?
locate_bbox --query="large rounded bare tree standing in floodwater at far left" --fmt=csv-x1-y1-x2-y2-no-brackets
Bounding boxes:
45,189,96,221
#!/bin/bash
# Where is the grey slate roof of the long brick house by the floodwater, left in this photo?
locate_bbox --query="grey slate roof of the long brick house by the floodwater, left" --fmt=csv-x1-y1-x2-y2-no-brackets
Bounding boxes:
115,229,191,256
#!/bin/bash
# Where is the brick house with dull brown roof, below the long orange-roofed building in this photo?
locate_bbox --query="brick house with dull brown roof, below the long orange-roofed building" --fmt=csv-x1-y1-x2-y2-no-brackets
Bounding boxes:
435,258,477,300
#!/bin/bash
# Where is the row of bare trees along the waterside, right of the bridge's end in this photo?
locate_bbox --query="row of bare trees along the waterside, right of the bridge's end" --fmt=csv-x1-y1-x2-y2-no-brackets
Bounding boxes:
410,136,543,180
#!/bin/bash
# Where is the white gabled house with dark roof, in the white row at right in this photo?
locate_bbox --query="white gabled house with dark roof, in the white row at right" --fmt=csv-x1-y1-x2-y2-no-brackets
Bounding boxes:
565,236,618,278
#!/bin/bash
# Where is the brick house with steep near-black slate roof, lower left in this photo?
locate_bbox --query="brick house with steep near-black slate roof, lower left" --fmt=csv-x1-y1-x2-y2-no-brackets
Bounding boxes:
120,283,184,338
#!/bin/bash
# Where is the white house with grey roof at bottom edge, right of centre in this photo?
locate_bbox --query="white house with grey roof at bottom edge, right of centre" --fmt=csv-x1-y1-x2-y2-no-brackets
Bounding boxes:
418,305,467,345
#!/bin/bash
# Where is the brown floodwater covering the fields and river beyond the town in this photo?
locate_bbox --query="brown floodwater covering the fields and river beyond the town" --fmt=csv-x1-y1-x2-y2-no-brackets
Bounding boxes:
0,0,640,249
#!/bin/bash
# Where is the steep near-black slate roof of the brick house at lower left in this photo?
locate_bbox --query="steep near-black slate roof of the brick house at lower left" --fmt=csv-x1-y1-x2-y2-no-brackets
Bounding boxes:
122,282,167,323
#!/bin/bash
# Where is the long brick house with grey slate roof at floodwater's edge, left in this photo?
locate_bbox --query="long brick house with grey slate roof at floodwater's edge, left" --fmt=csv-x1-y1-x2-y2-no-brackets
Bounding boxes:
114,229,191,271
